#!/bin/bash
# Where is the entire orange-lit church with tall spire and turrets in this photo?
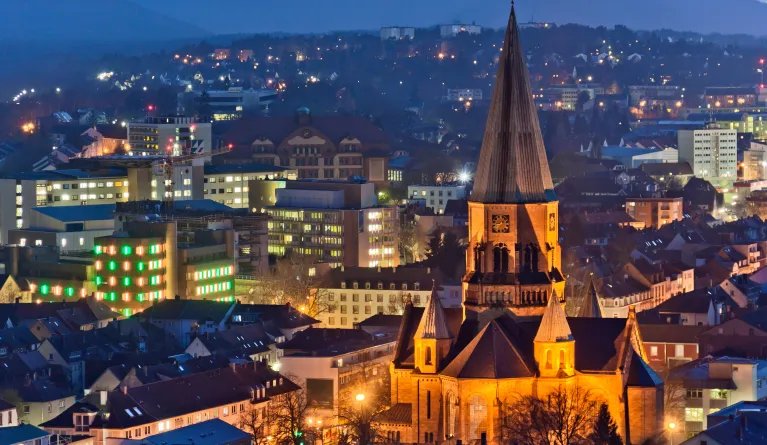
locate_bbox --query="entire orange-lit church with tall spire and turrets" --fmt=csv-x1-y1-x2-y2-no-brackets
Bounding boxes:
377,6,663,444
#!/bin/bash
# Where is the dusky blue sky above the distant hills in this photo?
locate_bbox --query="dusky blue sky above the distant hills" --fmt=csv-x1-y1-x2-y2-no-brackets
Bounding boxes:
134,0,767,35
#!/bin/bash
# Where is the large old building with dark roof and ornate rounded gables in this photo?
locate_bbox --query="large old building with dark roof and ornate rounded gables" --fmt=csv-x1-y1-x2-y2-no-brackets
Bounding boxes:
219,108,390,185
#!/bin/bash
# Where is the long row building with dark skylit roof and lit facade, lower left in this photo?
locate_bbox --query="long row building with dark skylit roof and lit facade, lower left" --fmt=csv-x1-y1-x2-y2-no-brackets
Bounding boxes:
40,363,298,445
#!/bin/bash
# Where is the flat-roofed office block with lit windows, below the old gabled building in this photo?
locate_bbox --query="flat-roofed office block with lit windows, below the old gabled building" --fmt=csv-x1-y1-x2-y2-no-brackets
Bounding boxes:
258,181,399,267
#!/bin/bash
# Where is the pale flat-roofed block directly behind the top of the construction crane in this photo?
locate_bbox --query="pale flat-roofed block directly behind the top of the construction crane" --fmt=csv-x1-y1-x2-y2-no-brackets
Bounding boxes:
128,116,215,156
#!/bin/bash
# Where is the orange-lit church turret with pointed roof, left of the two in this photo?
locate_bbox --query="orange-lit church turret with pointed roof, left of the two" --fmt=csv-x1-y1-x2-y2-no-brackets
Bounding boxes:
413,286,453,374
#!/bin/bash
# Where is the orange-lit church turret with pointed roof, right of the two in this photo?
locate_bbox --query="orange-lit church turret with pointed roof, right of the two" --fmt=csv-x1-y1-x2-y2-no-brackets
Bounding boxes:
533,294,575,377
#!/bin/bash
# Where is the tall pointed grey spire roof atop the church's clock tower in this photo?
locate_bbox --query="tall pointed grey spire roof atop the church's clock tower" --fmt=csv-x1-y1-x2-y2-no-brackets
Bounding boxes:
471,4,556,203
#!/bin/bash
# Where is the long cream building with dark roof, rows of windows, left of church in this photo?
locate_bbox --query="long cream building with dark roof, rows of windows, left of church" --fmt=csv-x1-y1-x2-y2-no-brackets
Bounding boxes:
312,266,461,329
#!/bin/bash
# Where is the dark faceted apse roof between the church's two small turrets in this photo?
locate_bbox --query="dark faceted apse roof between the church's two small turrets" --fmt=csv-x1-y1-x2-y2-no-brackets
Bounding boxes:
442,317,535,379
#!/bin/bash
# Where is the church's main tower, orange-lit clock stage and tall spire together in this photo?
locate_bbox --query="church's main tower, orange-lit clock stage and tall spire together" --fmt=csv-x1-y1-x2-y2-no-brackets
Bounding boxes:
463,2,565,316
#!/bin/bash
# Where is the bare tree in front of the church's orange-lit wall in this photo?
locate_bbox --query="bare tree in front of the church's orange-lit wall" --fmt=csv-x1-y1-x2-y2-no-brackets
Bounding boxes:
500,385,600,445
